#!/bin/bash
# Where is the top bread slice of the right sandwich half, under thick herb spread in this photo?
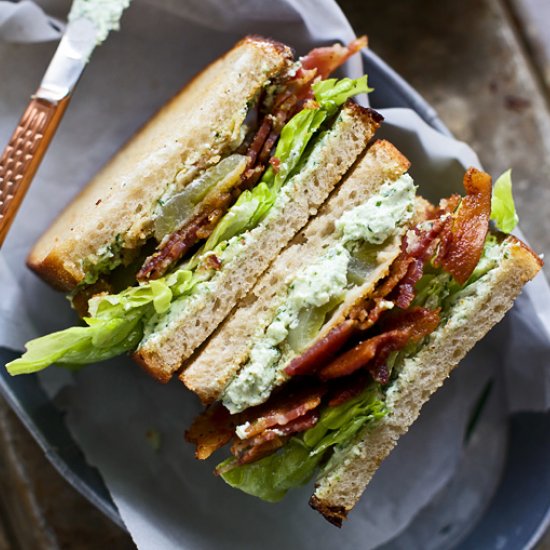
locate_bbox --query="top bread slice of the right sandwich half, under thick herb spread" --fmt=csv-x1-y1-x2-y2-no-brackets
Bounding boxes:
180,141,416,404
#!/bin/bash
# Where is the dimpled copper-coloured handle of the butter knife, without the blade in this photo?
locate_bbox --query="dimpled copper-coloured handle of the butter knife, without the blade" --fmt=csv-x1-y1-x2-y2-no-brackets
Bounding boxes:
0,96,70,247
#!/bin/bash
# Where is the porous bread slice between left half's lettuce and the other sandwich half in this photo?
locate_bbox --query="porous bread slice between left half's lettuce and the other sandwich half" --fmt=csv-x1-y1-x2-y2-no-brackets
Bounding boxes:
134,102,382,381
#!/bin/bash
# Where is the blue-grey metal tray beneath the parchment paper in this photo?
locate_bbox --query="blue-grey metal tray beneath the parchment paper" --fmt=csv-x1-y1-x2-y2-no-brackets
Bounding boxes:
0,51,550,550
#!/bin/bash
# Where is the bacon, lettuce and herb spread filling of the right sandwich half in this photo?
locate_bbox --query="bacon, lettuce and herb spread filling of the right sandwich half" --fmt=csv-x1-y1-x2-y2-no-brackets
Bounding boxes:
187,169,532,501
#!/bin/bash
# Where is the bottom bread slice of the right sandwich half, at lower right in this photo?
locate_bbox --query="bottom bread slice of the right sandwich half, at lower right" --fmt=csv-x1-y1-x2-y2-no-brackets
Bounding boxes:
310,237,542,526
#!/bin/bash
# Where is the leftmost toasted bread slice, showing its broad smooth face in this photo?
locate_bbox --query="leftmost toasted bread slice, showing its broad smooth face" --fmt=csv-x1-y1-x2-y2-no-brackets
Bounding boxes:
28,36,292,291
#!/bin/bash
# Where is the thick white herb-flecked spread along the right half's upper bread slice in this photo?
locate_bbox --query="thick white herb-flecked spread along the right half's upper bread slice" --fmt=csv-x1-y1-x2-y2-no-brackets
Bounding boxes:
223,174,415,414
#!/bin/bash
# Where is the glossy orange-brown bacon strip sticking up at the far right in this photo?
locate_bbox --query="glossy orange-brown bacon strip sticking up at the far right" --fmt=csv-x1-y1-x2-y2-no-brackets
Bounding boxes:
437,168,491,284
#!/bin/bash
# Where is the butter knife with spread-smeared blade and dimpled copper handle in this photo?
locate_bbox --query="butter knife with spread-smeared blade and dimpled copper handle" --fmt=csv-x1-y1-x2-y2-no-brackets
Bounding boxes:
0,0,130,247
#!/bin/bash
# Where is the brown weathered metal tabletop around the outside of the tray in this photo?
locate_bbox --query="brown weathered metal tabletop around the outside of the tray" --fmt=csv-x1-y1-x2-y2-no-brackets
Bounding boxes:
0,0,550,550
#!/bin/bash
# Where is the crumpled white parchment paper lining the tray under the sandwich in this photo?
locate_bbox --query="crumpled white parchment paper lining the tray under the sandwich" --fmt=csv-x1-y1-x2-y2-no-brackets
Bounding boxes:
0,0,550,549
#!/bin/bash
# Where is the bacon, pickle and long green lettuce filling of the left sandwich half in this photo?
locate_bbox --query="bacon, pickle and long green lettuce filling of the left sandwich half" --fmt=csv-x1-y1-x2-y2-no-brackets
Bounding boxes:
8,41,376,374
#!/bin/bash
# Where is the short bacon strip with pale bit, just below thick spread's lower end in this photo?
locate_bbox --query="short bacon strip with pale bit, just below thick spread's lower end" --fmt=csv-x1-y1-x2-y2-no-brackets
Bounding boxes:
238,386,326,439
